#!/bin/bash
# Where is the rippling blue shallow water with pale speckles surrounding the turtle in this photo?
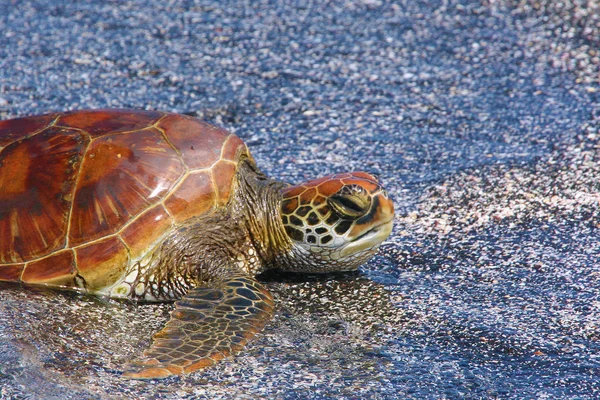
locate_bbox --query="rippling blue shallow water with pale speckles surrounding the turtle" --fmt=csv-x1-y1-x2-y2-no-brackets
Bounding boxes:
0,0,600,399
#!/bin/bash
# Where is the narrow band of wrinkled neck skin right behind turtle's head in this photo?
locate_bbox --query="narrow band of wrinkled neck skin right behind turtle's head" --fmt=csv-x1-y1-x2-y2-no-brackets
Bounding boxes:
232,160,292,274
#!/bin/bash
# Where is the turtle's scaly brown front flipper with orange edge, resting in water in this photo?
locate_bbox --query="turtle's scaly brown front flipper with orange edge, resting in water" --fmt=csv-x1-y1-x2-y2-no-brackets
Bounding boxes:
124,273,274,379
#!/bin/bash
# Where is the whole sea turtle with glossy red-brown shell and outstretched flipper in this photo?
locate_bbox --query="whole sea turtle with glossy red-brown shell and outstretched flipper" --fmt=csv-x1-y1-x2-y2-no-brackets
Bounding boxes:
0,110,394,379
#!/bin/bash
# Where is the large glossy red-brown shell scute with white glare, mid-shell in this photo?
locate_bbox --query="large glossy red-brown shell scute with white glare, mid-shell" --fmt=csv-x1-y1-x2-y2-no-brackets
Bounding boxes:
69,129,185,246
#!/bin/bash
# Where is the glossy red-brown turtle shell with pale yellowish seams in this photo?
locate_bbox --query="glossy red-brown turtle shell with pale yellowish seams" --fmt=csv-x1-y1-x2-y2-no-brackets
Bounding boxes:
0,110,251,290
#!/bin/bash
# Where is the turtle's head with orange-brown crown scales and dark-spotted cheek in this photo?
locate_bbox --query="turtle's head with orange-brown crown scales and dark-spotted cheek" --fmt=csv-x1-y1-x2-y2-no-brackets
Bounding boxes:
281,172,394,272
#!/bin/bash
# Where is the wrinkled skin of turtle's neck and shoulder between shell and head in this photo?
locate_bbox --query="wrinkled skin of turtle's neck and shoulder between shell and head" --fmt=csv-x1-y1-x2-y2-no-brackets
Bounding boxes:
126,160,292,301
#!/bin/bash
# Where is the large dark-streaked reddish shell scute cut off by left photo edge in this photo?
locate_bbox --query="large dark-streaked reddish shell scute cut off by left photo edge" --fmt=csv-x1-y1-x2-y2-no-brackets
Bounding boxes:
0,126,85,264
